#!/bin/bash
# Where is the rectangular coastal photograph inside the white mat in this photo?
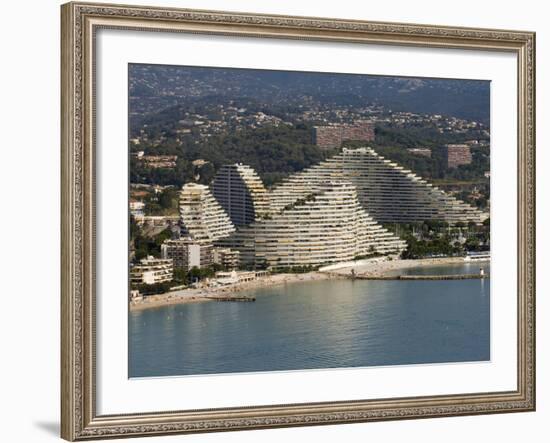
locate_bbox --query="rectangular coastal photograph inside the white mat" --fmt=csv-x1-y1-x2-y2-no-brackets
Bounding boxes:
128,63,496,378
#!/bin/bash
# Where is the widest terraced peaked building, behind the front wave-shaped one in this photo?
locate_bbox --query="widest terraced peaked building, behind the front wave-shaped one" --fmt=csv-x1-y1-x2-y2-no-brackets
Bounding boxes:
270,147,487,224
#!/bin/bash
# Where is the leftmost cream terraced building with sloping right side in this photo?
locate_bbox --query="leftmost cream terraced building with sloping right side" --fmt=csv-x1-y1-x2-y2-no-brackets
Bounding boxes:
179,183,235,242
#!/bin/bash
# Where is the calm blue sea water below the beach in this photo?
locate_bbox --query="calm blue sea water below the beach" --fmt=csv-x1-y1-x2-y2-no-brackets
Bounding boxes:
129,263,490,377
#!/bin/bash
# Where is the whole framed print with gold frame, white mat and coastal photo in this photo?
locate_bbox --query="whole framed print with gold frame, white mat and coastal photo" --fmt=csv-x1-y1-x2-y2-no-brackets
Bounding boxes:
61,3,535,440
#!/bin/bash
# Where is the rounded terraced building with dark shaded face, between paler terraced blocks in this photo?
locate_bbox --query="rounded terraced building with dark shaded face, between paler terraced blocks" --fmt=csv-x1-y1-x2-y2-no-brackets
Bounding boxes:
210,163,269,226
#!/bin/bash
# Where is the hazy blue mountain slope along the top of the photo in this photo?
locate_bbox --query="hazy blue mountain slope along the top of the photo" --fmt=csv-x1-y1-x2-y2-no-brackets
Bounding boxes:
129,64,490,124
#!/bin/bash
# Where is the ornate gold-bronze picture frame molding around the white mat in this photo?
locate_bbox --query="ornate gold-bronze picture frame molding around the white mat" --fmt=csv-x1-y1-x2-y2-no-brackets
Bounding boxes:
61,2,535,441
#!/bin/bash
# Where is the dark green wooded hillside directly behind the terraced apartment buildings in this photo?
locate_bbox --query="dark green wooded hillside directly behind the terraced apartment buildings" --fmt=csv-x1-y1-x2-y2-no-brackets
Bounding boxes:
134,120,490,211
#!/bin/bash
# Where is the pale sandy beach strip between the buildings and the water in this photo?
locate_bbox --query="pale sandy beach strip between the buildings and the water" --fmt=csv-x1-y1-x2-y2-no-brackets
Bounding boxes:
129,257,492,311
